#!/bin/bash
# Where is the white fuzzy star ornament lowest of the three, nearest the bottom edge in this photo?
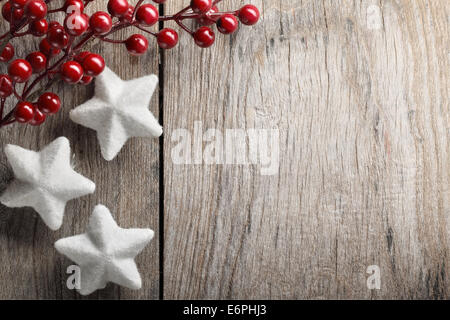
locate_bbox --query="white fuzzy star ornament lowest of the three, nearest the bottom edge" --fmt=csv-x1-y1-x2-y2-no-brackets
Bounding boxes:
55,205,154,295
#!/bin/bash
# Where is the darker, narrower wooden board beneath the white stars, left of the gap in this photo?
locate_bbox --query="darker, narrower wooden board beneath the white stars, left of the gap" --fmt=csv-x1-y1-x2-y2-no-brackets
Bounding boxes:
0,0,159,299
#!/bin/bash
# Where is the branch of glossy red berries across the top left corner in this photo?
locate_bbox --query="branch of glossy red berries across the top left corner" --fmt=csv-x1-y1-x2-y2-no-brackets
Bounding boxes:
0,0,259,127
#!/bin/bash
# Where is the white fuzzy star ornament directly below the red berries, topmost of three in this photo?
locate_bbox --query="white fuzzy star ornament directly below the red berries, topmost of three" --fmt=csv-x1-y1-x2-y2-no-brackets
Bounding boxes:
70,68,162,161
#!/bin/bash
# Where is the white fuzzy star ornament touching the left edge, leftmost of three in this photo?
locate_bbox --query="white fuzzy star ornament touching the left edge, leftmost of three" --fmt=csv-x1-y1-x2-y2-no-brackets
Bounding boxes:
0,137,95,230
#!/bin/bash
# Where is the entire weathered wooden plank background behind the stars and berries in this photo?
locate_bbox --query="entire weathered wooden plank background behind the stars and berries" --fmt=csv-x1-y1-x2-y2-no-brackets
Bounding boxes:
0,0,450,299
